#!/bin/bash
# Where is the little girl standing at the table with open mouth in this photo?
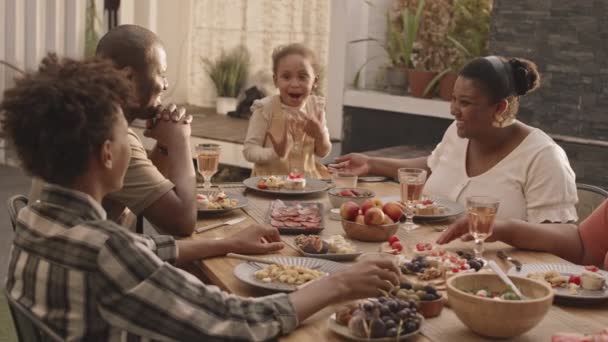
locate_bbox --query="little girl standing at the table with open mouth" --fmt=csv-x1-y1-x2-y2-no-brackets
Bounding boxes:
243,44,331,178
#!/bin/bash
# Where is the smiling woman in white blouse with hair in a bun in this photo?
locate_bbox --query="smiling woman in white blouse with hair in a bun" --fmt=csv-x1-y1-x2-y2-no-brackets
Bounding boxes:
330,56,578,223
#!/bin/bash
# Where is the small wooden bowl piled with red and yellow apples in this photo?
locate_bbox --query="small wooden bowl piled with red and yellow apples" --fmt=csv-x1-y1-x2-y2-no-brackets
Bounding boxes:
340,198,402,242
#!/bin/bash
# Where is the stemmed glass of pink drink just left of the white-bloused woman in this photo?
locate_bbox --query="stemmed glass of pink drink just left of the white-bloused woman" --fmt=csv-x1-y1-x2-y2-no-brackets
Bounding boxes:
398,168,426,231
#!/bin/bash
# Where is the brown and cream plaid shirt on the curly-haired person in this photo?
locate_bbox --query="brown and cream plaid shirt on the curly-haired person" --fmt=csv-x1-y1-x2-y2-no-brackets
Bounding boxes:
6,185,298,341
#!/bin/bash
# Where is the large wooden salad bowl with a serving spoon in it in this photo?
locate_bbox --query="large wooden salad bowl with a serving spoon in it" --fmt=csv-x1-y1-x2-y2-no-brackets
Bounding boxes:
447,273,553,338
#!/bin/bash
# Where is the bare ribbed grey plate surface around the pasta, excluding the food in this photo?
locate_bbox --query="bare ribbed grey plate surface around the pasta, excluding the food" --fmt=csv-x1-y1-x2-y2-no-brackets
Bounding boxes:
234,256,346,292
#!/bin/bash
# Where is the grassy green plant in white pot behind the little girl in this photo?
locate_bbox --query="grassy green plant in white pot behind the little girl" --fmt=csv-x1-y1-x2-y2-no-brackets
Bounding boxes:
202,46,249,114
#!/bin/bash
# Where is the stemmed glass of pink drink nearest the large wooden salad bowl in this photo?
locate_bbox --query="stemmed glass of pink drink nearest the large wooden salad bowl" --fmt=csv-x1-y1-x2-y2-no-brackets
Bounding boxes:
467,196,500,264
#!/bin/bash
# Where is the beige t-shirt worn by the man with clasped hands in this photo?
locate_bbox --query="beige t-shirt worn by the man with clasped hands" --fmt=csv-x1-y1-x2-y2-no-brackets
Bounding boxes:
29,129,175,222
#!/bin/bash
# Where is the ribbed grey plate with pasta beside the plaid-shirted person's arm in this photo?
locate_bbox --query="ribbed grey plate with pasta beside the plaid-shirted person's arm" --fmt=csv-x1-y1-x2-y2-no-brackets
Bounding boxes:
234,256,344,292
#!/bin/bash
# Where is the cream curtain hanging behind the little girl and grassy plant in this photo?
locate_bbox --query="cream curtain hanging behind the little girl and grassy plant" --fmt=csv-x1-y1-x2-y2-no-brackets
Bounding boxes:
188,0,331,106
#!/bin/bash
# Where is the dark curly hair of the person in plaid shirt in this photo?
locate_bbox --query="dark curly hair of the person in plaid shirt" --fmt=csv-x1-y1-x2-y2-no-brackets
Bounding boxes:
0,54,136,185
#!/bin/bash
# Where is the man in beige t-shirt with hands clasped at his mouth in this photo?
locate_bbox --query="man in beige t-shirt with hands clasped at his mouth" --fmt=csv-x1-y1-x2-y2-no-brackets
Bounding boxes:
30,25,196,236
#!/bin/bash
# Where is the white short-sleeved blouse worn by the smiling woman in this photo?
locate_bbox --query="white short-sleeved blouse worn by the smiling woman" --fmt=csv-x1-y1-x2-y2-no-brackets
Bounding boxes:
424,123,578,223
